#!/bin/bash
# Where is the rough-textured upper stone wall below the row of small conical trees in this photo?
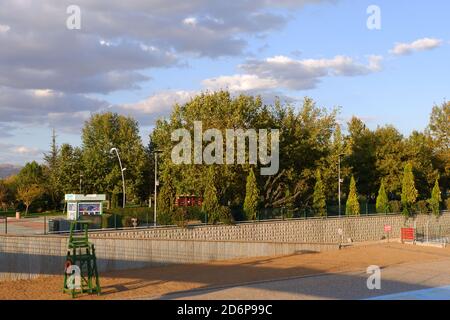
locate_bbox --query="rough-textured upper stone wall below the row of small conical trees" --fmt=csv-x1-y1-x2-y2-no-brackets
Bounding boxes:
91,212,450,243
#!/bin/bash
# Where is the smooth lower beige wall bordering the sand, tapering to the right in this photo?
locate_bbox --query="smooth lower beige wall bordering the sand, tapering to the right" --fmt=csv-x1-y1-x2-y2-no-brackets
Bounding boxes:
0,236,338,281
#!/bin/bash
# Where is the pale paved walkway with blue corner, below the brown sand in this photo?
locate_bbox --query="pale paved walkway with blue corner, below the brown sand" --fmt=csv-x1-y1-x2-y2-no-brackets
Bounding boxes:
159,259,450,300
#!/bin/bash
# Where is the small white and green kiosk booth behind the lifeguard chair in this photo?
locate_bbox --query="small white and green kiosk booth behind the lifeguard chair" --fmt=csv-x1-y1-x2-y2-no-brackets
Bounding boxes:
65,194,106,221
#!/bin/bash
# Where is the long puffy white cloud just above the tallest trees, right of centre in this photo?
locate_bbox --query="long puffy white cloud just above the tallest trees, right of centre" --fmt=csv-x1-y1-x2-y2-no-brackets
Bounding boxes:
202,56,382,91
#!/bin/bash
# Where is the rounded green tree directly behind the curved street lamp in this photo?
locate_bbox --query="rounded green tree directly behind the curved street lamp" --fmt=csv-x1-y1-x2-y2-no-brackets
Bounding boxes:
82,112,149,208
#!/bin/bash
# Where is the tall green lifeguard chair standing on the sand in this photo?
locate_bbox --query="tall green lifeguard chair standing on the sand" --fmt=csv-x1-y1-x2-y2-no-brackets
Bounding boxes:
63,221,101,298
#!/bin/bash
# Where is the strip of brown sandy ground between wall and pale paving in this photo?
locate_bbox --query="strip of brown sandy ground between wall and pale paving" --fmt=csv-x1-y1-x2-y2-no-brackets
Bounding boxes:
0,243,450,300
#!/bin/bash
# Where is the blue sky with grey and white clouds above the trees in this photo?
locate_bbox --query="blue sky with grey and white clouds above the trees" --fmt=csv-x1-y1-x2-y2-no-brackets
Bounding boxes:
0,0,450,165
